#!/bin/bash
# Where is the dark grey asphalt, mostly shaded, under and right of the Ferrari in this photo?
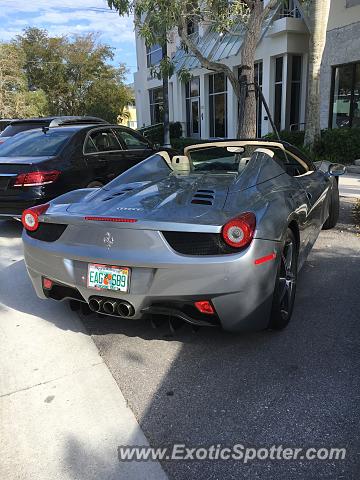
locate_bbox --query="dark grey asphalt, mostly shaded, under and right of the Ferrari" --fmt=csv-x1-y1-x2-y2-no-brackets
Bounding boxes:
84,198,360,480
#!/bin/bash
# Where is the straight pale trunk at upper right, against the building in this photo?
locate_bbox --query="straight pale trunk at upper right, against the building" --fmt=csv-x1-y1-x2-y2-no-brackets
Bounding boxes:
304,0,330,149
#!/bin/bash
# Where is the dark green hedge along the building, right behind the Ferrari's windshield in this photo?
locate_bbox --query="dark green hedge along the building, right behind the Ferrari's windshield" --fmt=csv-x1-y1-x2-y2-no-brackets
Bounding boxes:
265,128,360,163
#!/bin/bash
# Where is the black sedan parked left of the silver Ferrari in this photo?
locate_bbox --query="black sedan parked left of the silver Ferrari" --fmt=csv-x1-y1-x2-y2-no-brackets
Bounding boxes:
0,125,176,217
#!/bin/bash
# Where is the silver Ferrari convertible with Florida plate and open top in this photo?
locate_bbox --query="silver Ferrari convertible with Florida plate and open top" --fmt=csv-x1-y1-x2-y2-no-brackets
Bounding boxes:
22,140,345,331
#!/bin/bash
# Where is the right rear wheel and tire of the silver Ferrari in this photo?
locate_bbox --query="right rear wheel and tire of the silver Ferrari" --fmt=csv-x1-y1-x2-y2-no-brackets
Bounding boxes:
269,228,298,330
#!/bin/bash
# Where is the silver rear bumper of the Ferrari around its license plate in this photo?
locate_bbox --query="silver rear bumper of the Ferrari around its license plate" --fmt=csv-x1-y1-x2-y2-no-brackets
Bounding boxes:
23,233,280,331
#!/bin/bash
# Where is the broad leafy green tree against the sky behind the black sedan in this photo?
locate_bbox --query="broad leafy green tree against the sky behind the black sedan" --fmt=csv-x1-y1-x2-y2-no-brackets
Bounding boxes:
13,28,133,122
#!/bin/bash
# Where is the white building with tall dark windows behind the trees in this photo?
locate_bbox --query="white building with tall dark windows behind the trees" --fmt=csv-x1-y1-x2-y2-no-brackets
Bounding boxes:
135,0,360,138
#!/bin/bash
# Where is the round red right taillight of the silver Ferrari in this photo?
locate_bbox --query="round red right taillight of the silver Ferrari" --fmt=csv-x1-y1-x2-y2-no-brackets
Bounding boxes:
221,212,256,248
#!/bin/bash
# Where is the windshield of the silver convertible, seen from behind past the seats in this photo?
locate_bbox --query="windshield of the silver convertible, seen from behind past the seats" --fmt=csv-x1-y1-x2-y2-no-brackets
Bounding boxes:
189,145,257,173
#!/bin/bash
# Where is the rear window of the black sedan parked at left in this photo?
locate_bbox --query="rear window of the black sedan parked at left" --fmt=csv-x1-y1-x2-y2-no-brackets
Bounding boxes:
0,130,74,157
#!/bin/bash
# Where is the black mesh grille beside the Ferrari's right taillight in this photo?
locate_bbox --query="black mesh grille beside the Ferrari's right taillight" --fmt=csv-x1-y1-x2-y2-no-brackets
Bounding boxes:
162,232,239,255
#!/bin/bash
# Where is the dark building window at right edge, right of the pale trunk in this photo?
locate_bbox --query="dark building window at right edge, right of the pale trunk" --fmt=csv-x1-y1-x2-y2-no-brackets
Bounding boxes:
329,63,360,128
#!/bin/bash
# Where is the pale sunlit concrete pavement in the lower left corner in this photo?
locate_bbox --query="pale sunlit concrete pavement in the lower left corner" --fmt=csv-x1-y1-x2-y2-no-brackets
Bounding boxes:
0,221,166,480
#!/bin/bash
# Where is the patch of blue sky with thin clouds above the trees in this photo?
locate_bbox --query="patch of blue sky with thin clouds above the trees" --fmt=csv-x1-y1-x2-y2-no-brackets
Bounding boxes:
0,0,136,83
